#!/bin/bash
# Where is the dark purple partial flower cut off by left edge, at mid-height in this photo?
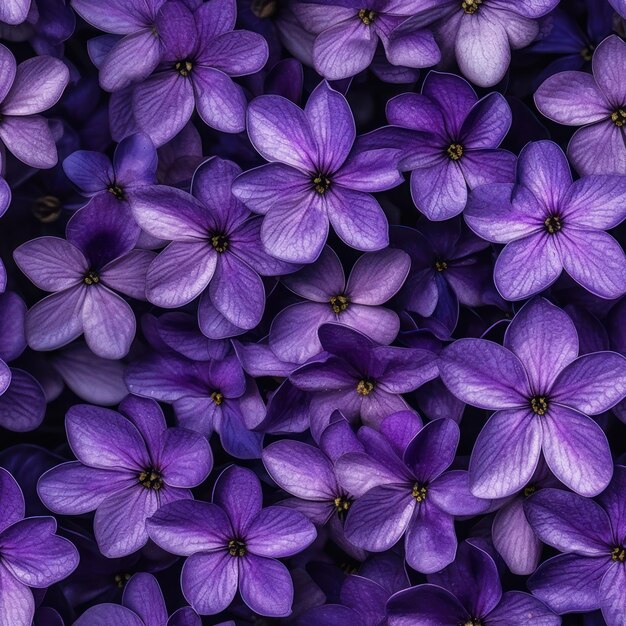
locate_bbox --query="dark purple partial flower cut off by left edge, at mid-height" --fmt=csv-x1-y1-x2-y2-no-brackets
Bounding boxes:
0,291,46,432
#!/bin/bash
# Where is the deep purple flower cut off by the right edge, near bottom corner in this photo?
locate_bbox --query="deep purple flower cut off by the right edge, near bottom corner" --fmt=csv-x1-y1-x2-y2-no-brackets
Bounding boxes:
524,465,626,626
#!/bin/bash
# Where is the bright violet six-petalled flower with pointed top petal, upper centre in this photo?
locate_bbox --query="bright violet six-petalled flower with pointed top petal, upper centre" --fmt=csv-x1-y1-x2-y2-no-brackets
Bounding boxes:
233,82,402,263
